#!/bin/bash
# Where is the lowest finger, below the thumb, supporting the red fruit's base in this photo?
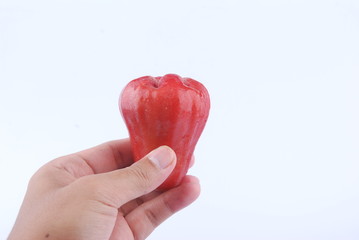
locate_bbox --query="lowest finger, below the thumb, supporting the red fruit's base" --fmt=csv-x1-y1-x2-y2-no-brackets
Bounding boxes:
125,176,200,239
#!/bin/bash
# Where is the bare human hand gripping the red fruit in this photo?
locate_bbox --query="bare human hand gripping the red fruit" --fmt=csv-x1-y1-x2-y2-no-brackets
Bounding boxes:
9,139,200,240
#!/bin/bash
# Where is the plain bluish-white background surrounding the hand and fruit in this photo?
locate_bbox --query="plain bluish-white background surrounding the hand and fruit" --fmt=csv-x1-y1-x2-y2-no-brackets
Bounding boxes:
0,0,359,240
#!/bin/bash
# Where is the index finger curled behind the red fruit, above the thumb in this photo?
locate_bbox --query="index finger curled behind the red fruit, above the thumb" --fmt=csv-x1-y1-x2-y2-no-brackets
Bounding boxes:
30,139,133,193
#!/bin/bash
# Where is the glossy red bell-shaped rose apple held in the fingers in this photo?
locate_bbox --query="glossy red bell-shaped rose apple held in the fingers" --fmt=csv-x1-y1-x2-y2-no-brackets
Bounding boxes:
119,74,210,190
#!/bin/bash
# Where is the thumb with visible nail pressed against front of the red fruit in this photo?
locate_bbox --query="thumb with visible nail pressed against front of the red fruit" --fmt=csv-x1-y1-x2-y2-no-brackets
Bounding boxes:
81,146,176,208
